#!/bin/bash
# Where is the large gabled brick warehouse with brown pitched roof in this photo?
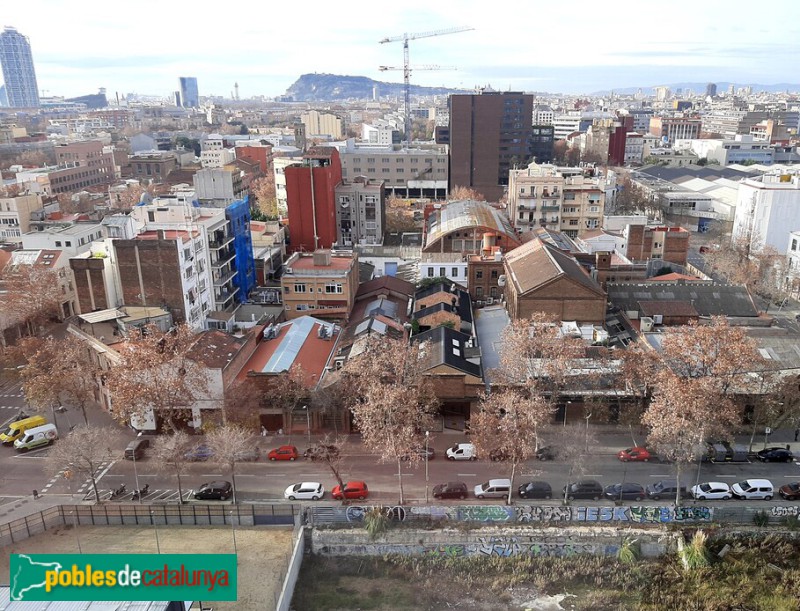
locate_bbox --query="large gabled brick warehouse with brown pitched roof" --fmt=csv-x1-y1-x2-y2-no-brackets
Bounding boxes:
503,239,606,324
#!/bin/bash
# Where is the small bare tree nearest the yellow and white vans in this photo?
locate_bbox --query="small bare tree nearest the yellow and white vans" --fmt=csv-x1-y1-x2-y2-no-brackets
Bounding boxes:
46,425,119,503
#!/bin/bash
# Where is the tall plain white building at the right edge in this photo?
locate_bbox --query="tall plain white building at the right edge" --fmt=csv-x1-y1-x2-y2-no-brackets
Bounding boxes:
732,173,800,252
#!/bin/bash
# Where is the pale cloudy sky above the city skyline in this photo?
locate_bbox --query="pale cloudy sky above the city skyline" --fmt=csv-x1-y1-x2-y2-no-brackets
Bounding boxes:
2,0,800,99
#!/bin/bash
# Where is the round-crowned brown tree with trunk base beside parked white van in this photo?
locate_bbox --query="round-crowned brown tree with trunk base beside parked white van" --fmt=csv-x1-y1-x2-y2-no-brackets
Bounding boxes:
470,389,553,505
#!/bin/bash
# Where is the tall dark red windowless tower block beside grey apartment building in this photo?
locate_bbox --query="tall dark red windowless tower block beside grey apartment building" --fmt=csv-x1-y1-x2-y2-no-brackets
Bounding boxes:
284,146,342,252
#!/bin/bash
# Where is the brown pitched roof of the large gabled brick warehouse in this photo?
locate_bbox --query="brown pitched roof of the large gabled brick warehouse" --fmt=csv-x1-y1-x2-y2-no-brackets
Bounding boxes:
505,239,604,295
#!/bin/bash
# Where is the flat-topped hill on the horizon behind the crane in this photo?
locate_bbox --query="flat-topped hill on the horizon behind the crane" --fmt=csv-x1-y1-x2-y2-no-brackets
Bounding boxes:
284,73,464,102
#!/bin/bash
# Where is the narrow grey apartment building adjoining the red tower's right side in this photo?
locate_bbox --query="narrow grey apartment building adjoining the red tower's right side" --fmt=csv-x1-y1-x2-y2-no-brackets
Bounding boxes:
336,176,386,246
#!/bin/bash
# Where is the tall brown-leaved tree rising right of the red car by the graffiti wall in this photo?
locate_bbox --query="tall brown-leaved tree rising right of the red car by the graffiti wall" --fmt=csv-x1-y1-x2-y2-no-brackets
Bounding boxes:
343,337,438,504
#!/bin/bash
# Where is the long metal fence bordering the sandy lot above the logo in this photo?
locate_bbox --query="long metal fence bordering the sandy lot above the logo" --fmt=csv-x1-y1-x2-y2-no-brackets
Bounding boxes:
0,504,300,547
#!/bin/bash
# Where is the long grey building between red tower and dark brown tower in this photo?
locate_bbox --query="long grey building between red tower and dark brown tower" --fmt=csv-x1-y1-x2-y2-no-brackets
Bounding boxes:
340,140,448,199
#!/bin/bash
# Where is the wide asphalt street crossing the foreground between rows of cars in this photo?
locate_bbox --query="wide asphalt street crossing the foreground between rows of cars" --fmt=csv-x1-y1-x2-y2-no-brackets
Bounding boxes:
0,388,800,506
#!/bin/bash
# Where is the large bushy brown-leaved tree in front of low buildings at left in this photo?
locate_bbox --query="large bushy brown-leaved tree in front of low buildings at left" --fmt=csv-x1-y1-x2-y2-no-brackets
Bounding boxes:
108,324,209,430
